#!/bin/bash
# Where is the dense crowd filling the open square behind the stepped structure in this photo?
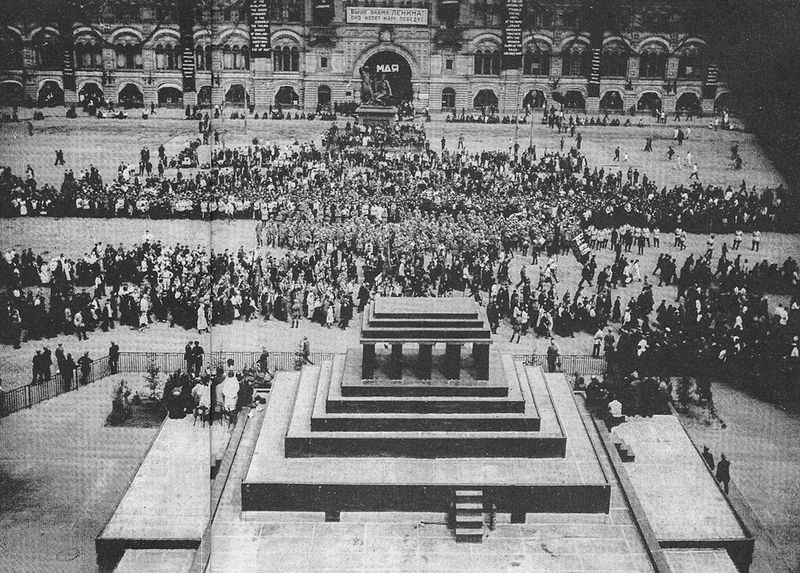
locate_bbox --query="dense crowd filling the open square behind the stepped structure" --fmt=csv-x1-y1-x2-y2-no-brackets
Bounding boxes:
0,124,800,416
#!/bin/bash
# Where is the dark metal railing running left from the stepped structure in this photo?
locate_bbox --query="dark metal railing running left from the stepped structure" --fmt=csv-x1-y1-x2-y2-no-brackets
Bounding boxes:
0,346,333,418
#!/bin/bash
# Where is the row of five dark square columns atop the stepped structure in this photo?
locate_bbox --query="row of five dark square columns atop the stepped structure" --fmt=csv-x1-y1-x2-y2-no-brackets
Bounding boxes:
361,342,489,380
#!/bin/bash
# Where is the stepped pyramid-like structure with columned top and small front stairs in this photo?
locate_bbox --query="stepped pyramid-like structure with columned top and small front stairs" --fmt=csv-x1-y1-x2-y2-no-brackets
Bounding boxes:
241,298,611,541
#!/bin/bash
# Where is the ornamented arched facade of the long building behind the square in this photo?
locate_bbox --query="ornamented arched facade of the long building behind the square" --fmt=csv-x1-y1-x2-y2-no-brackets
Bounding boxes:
0,0,731,114
